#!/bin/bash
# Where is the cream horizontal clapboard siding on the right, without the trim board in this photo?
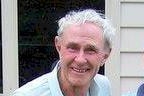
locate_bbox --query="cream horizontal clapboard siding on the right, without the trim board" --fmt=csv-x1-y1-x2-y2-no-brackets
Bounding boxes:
120,0,144,93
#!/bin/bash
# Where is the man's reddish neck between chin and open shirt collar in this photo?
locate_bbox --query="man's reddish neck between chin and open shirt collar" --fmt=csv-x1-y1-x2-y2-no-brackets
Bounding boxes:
58,71,90,96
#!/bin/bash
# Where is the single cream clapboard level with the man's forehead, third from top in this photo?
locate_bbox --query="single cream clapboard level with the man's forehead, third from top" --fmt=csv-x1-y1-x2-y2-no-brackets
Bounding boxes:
120,27,144,52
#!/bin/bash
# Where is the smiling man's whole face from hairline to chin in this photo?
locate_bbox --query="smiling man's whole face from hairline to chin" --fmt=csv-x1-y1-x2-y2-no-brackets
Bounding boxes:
55,23,109,86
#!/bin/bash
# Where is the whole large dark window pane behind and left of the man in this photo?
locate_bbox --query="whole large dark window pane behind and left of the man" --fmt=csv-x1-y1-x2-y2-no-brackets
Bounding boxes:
18,0,105,86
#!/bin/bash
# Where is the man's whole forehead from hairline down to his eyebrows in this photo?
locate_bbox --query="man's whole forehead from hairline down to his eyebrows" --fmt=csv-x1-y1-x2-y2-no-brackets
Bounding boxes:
62,23,104,47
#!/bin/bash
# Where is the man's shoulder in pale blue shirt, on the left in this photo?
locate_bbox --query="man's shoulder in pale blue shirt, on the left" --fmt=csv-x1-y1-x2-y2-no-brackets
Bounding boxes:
12,73,50,96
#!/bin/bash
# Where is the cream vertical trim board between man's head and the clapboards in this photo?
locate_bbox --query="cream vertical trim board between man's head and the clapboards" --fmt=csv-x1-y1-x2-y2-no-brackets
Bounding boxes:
105,0,121,96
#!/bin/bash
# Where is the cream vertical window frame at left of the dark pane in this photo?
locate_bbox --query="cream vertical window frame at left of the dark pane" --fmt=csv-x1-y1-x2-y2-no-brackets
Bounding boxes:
0,0,18,96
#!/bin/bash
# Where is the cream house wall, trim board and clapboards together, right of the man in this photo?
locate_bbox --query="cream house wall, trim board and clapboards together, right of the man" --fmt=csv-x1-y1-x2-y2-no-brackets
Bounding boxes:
106,0,144,96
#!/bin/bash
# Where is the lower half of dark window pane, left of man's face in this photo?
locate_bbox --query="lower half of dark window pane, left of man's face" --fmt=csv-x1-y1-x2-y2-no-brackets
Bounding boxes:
19,45,58,86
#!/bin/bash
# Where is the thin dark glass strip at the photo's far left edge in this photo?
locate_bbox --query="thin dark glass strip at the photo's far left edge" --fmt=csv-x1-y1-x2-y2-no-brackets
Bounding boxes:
0,1,3,93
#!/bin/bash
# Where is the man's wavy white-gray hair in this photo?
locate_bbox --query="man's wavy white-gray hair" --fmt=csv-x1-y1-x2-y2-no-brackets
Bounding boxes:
57,9,114,49
